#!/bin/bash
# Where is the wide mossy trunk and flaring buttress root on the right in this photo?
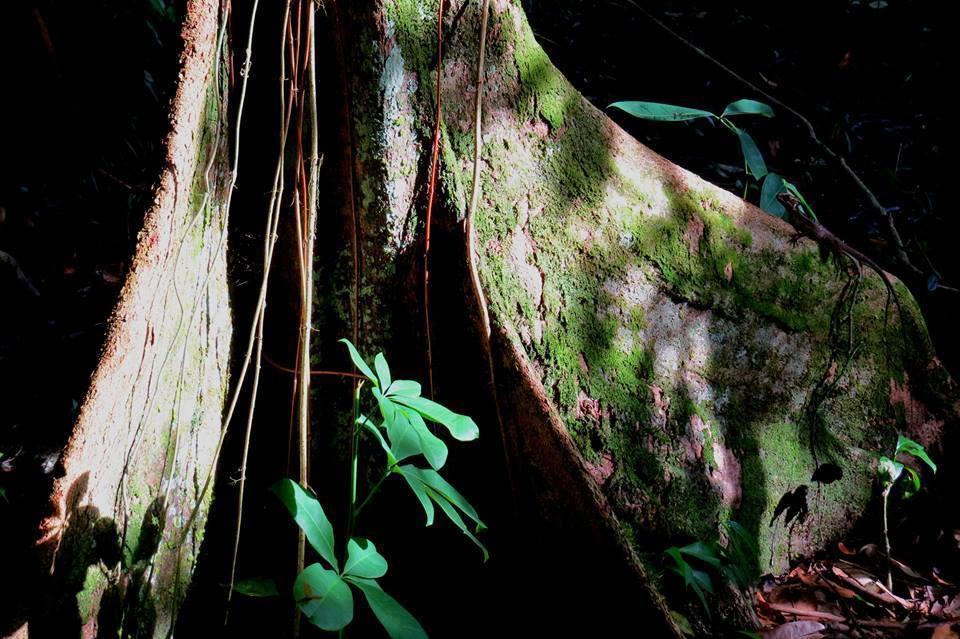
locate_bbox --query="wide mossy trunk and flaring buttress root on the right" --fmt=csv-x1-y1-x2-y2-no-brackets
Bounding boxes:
332,0,957,623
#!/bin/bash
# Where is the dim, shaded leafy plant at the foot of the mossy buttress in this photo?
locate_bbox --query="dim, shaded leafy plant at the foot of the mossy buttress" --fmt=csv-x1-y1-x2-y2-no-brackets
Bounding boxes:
664,520,759,616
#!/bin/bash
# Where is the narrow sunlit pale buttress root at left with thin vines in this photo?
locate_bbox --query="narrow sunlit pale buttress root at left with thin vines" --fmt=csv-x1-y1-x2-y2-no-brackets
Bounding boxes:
29,0,231,637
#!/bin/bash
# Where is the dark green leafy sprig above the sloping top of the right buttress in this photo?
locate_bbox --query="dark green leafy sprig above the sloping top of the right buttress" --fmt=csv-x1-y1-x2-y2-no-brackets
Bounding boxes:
610,99,817,220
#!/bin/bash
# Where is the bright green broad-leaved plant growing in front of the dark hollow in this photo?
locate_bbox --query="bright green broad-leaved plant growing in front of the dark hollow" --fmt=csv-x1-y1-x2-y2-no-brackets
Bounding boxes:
234,339,488,639
